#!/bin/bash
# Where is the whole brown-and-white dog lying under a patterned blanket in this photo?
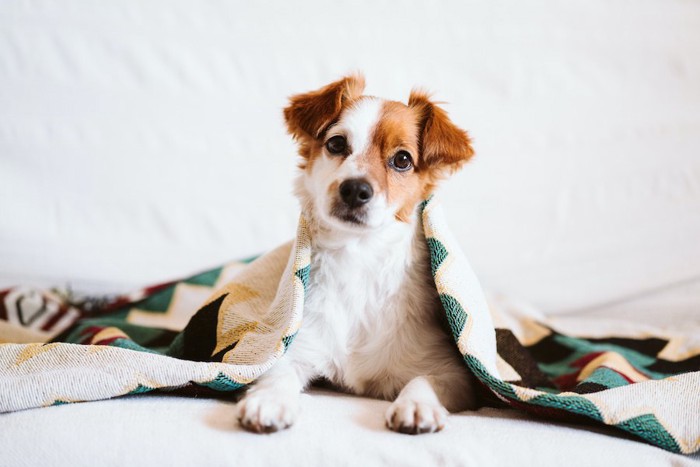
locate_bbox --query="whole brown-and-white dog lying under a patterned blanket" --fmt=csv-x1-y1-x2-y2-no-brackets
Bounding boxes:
236,75,476,434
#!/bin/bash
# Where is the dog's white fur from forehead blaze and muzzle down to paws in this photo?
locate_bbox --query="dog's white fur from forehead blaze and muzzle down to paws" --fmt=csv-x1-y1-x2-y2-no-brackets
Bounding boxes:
237,90,474,433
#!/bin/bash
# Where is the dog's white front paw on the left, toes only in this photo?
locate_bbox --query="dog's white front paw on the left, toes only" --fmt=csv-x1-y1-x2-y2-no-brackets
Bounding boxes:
236,392,299,433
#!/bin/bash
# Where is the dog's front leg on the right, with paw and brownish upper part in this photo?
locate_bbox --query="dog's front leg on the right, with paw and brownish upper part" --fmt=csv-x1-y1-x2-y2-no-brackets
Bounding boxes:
386,375,475,434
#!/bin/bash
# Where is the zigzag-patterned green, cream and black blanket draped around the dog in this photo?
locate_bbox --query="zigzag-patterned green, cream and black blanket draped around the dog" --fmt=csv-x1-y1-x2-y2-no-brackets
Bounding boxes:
0,200,700,454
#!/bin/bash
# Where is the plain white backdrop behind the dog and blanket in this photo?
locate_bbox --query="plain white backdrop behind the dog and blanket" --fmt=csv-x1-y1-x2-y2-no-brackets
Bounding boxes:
0,0,700,315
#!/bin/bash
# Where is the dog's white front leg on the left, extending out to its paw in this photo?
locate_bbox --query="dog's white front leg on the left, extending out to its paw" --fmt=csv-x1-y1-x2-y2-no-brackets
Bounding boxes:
236,357,308,433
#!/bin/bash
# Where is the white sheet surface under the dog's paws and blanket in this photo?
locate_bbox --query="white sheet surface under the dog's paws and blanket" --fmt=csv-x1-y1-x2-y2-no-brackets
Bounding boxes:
0,389,700,467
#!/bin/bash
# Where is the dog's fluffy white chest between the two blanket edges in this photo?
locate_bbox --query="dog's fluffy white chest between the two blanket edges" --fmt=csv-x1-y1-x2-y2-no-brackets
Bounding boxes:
299,232,436,393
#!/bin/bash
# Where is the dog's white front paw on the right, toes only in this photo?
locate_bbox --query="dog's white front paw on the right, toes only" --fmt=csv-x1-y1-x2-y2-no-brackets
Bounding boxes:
386,398,447,435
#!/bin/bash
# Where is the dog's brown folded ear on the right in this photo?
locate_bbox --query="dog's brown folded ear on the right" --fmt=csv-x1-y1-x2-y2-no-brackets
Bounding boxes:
408,89,474,171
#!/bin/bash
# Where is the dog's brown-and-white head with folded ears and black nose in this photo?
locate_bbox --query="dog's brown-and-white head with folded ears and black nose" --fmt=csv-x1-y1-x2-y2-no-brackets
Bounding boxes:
284,76,473,230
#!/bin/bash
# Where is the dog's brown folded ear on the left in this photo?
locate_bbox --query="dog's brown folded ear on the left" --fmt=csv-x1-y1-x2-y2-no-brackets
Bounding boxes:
284,74,365,139
